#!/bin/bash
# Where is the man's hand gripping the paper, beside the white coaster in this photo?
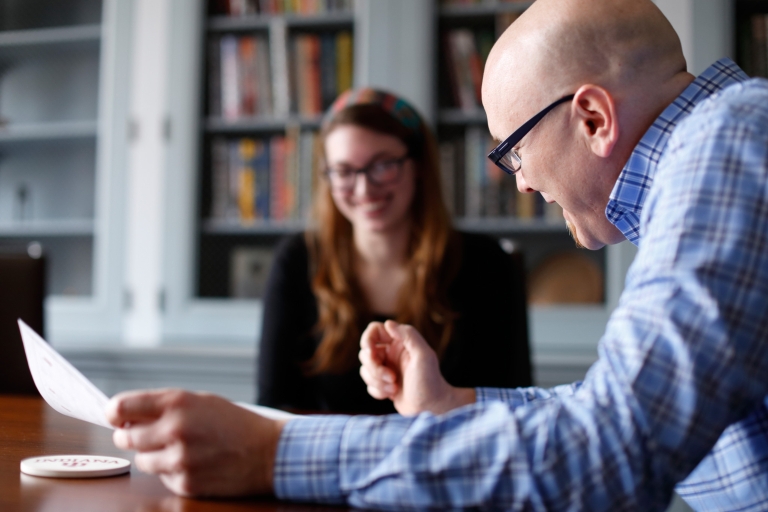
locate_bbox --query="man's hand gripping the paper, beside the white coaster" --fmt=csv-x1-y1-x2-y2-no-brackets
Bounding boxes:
106,390,285,496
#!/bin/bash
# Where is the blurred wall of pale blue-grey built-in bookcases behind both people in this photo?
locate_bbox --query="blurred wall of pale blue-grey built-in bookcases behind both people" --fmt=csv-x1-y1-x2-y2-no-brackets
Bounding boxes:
0,0,744,401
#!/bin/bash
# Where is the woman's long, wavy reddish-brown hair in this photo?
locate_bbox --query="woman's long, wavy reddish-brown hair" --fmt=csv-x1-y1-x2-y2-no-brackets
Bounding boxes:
305,104,461,374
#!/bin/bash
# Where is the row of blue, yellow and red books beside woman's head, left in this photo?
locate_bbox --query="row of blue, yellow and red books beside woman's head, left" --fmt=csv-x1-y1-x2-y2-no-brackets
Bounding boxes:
211,128,320,222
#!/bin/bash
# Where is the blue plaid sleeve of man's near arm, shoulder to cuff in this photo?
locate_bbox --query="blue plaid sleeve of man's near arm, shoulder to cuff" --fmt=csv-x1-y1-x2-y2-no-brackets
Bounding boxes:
275,109,768,510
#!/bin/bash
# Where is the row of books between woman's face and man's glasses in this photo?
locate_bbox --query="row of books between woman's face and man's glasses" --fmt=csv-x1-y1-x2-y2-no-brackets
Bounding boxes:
440,126,563,221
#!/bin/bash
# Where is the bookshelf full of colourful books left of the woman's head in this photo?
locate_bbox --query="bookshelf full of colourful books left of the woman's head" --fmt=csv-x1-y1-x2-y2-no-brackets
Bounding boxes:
196,0,354,299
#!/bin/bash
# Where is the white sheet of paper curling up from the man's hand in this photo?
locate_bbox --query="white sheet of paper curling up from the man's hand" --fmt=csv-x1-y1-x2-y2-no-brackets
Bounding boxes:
19,320,113,428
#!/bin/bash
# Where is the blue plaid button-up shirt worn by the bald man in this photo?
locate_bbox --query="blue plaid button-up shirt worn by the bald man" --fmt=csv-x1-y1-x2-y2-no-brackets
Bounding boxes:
274,60,768,511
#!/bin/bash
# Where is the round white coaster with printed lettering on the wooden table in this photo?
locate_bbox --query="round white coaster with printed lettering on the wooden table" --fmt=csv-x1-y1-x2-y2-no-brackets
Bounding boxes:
21,455,131,478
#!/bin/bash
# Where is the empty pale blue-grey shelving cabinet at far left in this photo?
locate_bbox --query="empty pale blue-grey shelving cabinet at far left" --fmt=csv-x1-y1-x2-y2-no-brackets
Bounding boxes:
0,0,131,343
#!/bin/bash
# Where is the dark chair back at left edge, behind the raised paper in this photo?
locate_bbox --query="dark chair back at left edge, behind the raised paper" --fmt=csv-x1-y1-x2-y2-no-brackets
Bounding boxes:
0,252,45,396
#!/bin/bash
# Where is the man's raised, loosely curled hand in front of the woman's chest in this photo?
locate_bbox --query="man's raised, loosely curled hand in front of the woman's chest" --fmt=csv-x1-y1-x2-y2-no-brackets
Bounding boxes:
359,320,475,416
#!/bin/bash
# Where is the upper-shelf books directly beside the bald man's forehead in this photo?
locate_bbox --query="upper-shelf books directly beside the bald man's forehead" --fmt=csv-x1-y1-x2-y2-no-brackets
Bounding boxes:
442,13,520,111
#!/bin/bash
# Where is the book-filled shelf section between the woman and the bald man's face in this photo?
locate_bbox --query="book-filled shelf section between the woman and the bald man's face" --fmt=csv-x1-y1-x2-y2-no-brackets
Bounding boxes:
434,0,613,312
